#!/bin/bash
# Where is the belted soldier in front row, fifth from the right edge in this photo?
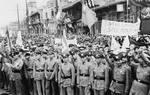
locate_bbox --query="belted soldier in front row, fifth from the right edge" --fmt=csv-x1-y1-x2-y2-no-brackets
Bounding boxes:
59,52,75,95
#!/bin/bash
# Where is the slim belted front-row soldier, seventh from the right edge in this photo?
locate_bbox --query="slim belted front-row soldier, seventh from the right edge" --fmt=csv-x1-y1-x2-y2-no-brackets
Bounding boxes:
33,50,45,95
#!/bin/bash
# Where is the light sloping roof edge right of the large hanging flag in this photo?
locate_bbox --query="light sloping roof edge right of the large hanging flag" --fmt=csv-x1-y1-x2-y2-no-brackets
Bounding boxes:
92,0,126,10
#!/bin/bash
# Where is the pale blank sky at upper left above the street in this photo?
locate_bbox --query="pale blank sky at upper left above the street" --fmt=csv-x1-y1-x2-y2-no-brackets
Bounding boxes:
0,0,47,34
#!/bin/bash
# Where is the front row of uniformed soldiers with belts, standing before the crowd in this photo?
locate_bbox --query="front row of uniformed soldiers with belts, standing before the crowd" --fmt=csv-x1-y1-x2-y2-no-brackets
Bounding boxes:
2,45,150,95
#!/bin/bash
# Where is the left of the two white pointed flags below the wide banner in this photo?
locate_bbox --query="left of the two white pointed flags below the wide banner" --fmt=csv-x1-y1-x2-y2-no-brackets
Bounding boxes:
110,37,121,54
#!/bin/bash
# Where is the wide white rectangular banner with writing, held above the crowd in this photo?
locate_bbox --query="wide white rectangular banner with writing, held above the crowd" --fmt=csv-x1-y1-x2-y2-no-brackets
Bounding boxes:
101,20,140,36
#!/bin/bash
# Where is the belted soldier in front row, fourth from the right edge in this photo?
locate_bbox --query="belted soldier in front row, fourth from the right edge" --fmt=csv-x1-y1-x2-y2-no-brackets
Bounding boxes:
77,52,91,95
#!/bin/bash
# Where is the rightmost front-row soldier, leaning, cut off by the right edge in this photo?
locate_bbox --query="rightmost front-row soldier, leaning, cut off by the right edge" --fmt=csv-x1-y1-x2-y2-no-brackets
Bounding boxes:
129,50,150,95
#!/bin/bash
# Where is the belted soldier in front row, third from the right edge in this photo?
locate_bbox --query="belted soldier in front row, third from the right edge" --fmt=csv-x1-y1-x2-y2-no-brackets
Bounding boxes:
91,52,109,95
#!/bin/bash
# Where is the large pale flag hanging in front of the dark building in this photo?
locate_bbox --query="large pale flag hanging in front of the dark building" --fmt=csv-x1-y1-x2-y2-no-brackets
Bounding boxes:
82,4,98,29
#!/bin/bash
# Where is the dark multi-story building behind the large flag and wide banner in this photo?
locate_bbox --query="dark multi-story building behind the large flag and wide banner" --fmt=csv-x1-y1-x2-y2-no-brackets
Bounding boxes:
62,0,137,34
